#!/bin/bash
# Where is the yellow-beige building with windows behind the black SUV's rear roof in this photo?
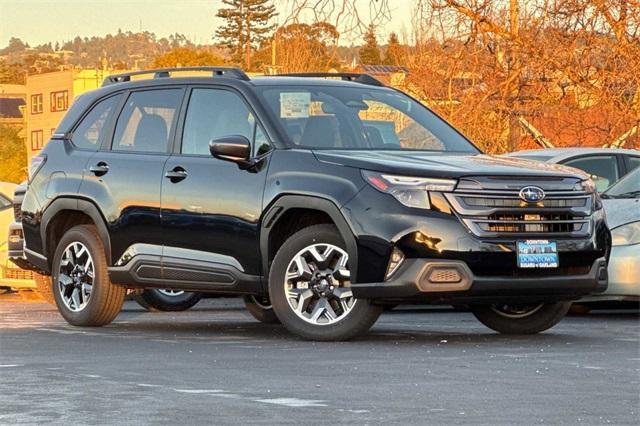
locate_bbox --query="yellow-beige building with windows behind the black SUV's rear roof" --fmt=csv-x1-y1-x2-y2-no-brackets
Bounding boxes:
25,70,123,160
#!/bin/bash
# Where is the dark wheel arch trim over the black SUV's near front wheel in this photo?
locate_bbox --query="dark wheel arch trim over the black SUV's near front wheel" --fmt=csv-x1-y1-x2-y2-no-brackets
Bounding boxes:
260,195,358,282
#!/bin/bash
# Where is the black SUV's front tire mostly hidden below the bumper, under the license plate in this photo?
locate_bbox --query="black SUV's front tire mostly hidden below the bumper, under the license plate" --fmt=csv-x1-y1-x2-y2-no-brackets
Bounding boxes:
471,302,571,334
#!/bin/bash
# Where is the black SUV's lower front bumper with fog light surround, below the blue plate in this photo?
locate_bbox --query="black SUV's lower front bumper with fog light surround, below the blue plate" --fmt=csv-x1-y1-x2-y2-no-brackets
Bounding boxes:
351,258,607,304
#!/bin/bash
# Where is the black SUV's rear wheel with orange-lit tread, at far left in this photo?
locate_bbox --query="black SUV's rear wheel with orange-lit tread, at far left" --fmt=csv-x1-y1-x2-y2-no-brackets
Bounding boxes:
52,225,126,327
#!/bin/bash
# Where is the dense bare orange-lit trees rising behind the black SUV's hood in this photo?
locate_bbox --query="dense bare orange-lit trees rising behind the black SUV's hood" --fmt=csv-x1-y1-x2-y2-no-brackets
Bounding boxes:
407,0,640,152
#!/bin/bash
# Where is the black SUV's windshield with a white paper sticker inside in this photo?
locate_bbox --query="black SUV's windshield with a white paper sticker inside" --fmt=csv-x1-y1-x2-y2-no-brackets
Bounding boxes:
255,85,479,153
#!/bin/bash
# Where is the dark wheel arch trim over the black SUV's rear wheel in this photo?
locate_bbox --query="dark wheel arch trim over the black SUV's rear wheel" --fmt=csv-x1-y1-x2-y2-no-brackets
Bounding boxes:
40,197,111,265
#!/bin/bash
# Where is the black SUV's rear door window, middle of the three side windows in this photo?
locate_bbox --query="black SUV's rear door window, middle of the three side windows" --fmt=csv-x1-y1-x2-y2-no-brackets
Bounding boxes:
111,89,183,153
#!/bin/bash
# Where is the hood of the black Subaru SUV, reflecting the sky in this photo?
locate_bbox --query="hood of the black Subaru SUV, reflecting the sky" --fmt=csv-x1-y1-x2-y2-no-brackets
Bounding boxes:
314,150,588,179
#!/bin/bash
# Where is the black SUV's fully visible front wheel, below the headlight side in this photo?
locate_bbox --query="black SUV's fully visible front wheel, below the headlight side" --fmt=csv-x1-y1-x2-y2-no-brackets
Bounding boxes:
269,224,382,341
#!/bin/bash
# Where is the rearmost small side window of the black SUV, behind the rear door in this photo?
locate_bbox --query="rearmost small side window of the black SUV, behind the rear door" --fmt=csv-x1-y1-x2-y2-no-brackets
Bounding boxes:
71,95,122,151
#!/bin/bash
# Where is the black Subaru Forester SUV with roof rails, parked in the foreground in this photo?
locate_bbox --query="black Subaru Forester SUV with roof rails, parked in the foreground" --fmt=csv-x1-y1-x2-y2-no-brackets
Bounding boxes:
11,67,610,340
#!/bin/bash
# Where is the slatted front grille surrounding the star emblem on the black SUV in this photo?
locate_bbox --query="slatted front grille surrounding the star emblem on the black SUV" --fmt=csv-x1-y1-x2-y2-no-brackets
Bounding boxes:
446,177,593,238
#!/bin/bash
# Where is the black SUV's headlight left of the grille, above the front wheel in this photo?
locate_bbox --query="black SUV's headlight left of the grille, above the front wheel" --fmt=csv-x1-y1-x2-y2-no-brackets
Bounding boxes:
362,171,456,209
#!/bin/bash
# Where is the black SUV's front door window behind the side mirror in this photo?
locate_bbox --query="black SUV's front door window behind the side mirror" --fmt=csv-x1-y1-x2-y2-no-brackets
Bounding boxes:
182,89,258,155
